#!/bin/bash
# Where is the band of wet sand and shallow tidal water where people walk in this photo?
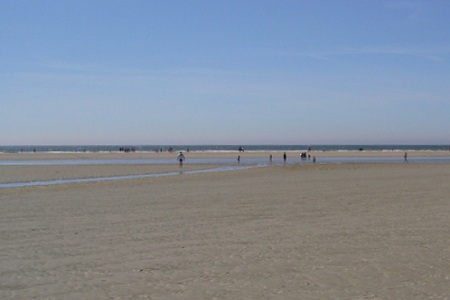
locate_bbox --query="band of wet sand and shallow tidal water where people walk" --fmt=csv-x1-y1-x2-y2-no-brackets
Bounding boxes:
0,151,450,188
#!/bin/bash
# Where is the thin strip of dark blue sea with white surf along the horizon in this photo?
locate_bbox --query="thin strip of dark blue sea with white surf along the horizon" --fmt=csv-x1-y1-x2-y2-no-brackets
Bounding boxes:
0,144,450,153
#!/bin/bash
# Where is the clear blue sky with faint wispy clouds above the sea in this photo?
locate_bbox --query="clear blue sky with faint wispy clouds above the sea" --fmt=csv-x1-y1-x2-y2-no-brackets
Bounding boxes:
0,0,450,145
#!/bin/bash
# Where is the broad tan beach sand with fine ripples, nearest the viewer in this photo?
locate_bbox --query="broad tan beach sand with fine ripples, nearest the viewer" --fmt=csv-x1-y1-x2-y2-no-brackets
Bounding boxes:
0,154,450,299
